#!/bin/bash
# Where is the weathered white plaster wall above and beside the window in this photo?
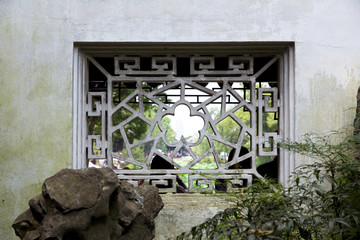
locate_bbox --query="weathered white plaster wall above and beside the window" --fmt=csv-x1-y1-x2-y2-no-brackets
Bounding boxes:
0,0,360,240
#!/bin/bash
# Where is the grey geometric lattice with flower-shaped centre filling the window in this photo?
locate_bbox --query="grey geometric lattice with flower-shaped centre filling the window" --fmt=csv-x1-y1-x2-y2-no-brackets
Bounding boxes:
85,55,281,192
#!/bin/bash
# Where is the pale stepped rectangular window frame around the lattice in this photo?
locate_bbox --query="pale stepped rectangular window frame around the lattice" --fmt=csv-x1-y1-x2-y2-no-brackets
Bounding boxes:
72,42,296,185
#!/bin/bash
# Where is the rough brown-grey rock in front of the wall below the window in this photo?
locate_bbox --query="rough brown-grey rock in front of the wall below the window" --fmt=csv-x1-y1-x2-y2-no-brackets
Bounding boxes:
12,168,164,240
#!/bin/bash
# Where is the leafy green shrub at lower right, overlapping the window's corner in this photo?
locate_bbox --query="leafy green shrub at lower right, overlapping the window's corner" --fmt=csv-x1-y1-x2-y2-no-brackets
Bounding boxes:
175,132,360,240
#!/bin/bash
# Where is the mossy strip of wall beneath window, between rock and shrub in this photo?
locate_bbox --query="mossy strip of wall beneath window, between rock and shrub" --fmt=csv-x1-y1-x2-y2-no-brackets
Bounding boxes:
155,193,234,240
